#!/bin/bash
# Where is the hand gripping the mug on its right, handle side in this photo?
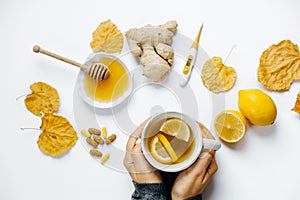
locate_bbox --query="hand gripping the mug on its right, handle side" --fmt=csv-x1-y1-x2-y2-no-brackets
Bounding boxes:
171,123,218,200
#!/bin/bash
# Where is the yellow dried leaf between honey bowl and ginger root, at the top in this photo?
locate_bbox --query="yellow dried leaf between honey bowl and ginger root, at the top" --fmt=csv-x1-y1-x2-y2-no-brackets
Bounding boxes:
90,20,124,53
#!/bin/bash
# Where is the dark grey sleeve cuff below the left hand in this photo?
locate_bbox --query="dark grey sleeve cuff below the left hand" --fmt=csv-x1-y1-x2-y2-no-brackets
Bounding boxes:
131,181,167,200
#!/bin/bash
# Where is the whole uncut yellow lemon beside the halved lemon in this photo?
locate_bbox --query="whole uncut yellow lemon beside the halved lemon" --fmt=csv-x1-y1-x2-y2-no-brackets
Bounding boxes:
238,89,277,126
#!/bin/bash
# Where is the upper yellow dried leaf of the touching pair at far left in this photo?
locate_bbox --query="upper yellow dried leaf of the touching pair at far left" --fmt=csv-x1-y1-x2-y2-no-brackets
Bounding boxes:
25,82,59,116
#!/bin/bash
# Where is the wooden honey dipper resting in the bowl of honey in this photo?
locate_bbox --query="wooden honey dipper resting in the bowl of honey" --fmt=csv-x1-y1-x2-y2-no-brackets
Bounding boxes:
33,45,110,81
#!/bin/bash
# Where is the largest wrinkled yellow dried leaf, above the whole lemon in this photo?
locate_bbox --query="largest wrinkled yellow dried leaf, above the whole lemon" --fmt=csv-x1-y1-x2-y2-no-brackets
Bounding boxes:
257,40,300,91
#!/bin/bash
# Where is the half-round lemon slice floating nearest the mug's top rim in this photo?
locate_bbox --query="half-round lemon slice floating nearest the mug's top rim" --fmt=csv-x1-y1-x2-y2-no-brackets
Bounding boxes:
160,118,191,142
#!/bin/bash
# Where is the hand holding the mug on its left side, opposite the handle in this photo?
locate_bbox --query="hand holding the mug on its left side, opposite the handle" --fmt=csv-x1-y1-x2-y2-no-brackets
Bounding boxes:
123,120,162,183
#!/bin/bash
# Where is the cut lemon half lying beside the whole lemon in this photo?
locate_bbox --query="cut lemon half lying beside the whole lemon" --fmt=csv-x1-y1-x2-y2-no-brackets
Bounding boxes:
214,110,247,143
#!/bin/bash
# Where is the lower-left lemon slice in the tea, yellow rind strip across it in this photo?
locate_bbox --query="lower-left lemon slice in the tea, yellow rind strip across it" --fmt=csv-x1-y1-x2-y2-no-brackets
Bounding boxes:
150,133,178,164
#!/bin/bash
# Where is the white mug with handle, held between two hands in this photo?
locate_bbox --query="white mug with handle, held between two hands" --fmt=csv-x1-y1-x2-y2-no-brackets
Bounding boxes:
141,112,221,172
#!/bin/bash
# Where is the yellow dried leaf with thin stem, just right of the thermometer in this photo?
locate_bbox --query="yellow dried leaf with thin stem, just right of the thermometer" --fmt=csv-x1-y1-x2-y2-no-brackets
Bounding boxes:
201,57,236,93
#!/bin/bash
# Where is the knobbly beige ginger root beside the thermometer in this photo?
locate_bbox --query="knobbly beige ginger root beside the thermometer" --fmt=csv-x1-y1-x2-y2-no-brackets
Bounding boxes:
125,21,178,82
